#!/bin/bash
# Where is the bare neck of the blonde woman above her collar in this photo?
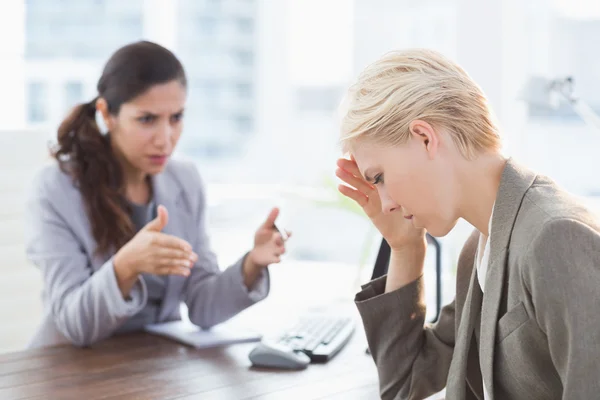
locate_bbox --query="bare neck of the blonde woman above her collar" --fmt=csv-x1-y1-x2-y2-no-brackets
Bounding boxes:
459,154,506,236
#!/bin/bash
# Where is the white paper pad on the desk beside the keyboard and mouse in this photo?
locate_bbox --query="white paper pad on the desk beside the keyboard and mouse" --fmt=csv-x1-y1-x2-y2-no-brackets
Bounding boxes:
144,321,262,349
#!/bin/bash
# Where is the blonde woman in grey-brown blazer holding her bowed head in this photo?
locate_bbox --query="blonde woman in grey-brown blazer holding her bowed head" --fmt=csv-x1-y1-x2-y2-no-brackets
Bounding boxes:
337,50,600,400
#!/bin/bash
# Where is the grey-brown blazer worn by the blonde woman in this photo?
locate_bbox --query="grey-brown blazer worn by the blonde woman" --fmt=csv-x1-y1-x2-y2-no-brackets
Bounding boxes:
356,160,600,400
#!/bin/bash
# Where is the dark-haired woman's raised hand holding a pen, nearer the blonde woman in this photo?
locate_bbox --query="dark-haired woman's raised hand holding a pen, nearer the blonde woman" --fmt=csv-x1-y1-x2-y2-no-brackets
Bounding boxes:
244,208,291,287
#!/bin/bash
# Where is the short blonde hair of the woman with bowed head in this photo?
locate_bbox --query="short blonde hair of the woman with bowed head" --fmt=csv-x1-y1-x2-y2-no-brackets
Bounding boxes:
341,49,501,159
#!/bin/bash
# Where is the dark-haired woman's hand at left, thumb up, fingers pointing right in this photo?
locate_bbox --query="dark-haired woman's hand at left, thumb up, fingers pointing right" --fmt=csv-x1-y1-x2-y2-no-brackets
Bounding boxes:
113,206,198,295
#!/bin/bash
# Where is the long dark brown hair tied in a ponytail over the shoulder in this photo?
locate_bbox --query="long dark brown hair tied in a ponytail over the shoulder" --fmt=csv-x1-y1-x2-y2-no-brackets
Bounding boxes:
52,41,186,254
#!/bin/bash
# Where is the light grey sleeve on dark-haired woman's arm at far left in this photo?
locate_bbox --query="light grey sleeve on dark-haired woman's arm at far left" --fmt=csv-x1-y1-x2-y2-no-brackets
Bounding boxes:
26,174,146,346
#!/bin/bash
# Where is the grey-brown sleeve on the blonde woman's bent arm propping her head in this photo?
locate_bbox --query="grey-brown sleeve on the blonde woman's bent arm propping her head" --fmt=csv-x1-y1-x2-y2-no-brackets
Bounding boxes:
356,270,455,399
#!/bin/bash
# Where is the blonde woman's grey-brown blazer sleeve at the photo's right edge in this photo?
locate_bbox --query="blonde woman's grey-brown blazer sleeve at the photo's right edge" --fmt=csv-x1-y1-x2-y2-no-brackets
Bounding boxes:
523,219,600,399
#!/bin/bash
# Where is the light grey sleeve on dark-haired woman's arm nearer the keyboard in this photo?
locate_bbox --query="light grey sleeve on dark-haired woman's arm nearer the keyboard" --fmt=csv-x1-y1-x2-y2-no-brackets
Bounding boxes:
184,165,270,329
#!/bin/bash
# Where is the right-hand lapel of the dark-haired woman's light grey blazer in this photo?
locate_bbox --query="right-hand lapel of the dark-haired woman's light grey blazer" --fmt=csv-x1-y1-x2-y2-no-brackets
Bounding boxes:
152,169,188,321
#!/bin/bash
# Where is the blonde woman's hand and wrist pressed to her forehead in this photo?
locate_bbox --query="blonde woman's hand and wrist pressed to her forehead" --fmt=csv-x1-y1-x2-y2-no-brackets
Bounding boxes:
336,158,426,251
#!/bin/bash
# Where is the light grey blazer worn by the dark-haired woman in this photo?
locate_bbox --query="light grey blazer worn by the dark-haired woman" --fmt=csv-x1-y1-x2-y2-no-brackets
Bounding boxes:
26,160,269,347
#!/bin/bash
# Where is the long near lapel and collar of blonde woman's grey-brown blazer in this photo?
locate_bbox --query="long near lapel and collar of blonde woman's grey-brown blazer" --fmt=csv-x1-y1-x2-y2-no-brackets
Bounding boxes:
476,160,535,400
